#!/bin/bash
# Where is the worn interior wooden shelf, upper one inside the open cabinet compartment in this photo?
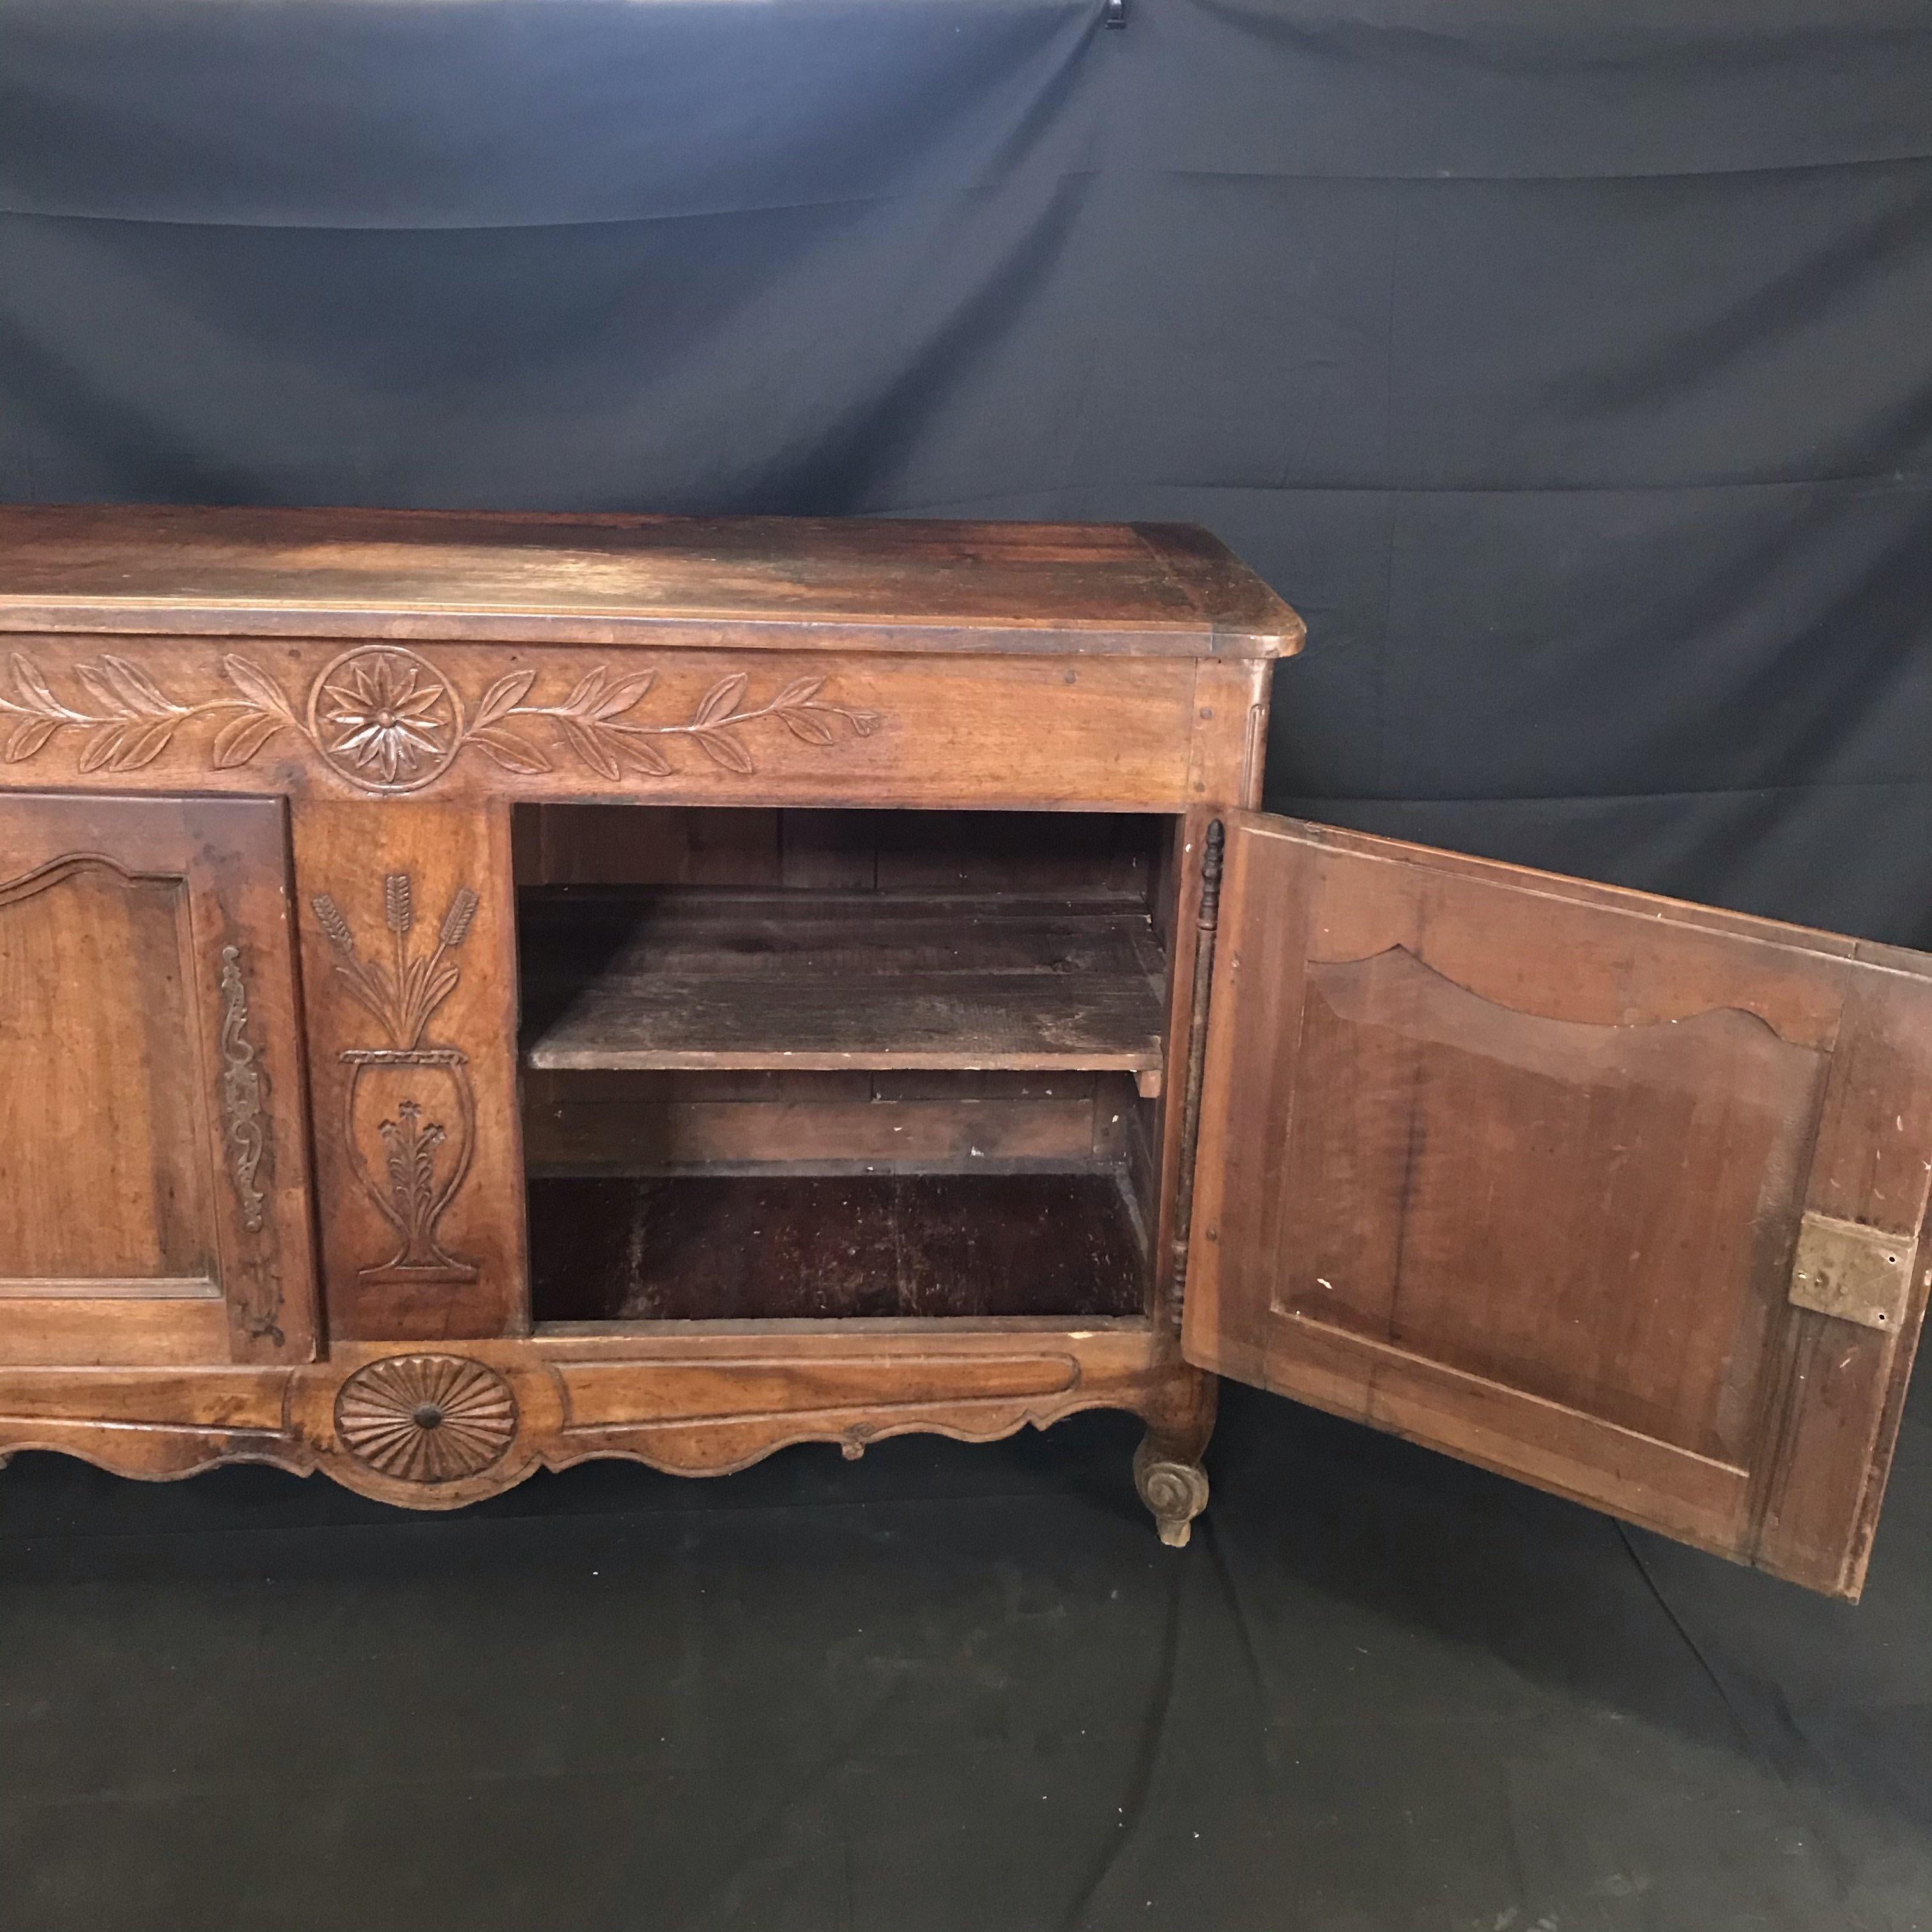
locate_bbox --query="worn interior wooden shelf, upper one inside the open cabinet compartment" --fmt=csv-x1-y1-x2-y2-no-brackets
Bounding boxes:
519,887,1165,1094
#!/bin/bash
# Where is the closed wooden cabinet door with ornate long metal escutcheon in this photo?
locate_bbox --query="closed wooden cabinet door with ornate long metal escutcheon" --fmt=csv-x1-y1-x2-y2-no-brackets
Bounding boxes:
0,794,315,1366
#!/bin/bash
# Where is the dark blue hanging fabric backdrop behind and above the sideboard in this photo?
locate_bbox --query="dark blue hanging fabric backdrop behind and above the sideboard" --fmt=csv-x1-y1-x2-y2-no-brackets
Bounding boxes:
0,0,1932,945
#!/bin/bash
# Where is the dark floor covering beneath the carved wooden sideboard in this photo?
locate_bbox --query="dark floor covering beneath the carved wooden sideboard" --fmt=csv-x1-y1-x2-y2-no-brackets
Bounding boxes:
0,1389,1932,1932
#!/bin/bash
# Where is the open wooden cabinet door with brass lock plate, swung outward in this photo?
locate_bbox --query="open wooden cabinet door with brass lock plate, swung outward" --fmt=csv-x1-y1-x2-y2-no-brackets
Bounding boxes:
1183,813,1932,1598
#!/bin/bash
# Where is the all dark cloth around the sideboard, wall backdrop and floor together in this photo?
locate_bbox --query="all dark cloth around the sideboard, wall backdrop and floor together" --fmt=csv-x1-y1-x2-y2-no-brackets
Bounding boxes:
11,15,1932,1932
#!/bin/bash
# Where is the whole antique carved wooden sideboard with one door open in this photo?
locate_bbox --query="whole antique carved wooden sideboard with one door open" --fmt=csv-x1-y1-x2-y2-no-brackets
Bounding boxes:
0,508,1932,1596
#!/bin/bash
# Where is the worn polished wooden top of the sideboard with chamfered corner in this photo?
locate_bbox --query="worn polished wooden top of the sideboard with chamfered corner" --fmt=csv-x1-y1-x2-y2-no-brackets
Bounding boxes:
0,504,1302,659
